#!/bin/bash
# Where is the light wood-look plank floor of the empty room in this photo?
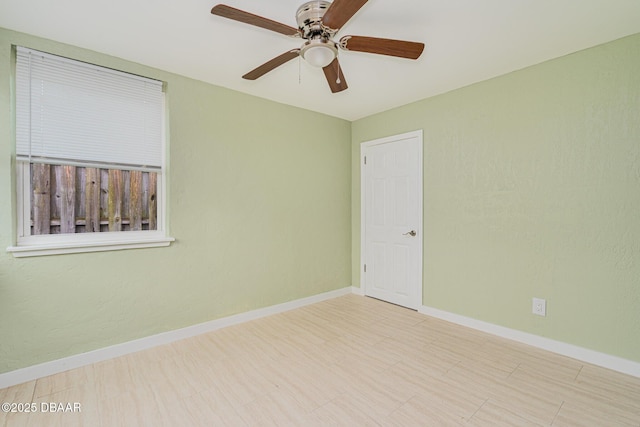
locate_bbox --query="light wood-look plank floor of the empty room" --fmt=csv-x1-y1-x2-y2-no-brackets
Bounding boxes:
0,295,640,427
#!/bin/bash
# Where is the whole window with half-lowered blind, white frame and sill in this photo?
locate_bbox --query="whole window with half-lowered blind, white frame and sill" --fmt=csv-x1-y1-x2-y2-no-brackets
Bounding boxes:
8,47,173,256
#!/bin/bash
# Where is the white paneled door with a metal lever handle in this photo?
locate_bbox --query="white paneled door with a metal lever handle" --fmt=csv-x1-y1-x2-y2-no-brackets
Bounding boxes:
361,131,422,309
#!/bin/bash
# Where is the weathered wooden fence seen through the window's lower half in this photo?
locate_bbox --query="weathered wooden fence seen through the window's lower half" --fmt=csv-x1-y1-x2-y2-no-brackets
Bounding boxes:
31,164,158,235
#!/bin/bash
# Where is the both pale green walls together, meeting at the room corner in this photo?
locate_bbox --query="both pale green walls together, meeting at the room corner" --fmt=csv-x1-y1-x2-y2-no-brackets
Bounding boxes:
0,29,640,373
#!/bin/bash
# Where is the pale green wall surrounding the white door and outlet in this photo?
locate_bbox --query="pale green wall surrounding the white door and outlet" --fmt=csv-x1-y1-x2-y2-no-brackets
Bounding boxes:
351,35,640,362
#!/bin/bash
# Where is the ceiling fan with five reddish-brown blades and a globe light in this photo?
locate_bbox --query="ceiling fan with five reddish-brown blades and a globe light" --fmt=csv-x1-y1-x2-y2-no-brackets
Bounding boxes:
211,0,424,93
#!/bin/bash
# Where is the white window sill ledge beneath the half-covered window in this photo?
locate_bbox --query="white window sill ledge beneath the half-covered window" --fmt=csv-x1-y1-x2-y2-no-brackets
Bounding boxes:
7,231,175,258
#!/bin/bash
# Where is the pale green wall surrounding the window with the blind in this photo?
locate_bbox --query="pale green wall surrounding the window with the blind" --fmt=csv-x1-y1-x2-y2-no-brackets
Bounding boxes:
0,29,351,373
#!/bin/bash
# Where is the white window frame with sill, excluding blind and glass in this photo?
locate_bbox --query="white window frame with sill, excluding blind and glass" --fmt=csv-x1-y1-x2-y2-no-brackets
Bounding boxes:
7,47,175,258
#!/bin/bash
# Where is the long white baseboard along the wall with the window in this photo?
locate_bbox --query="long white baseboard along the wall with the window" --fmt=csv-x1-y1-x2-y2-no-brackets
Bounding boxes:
0,287,353,389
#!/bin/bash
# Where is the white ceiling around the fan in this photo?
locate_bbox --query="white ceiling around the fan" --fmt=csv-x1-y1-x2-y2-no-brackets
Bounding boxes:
0,0,640,120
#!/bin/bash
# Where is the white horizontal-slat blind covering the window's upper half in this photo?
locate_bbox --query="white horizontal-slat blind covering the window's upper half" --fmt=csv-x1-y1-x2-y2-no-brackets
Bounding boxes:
16,47,164,171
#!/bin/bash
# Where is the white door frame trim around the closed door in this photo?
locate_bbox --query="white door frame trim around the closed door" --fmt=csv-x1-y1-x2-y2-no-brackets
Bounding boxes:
360,129,424,310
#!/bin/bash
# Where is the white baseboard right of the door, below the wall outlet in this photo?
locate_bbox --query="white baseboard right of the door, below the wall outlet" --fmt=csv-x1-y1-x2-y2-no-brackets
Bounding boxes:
418,306,640,378
